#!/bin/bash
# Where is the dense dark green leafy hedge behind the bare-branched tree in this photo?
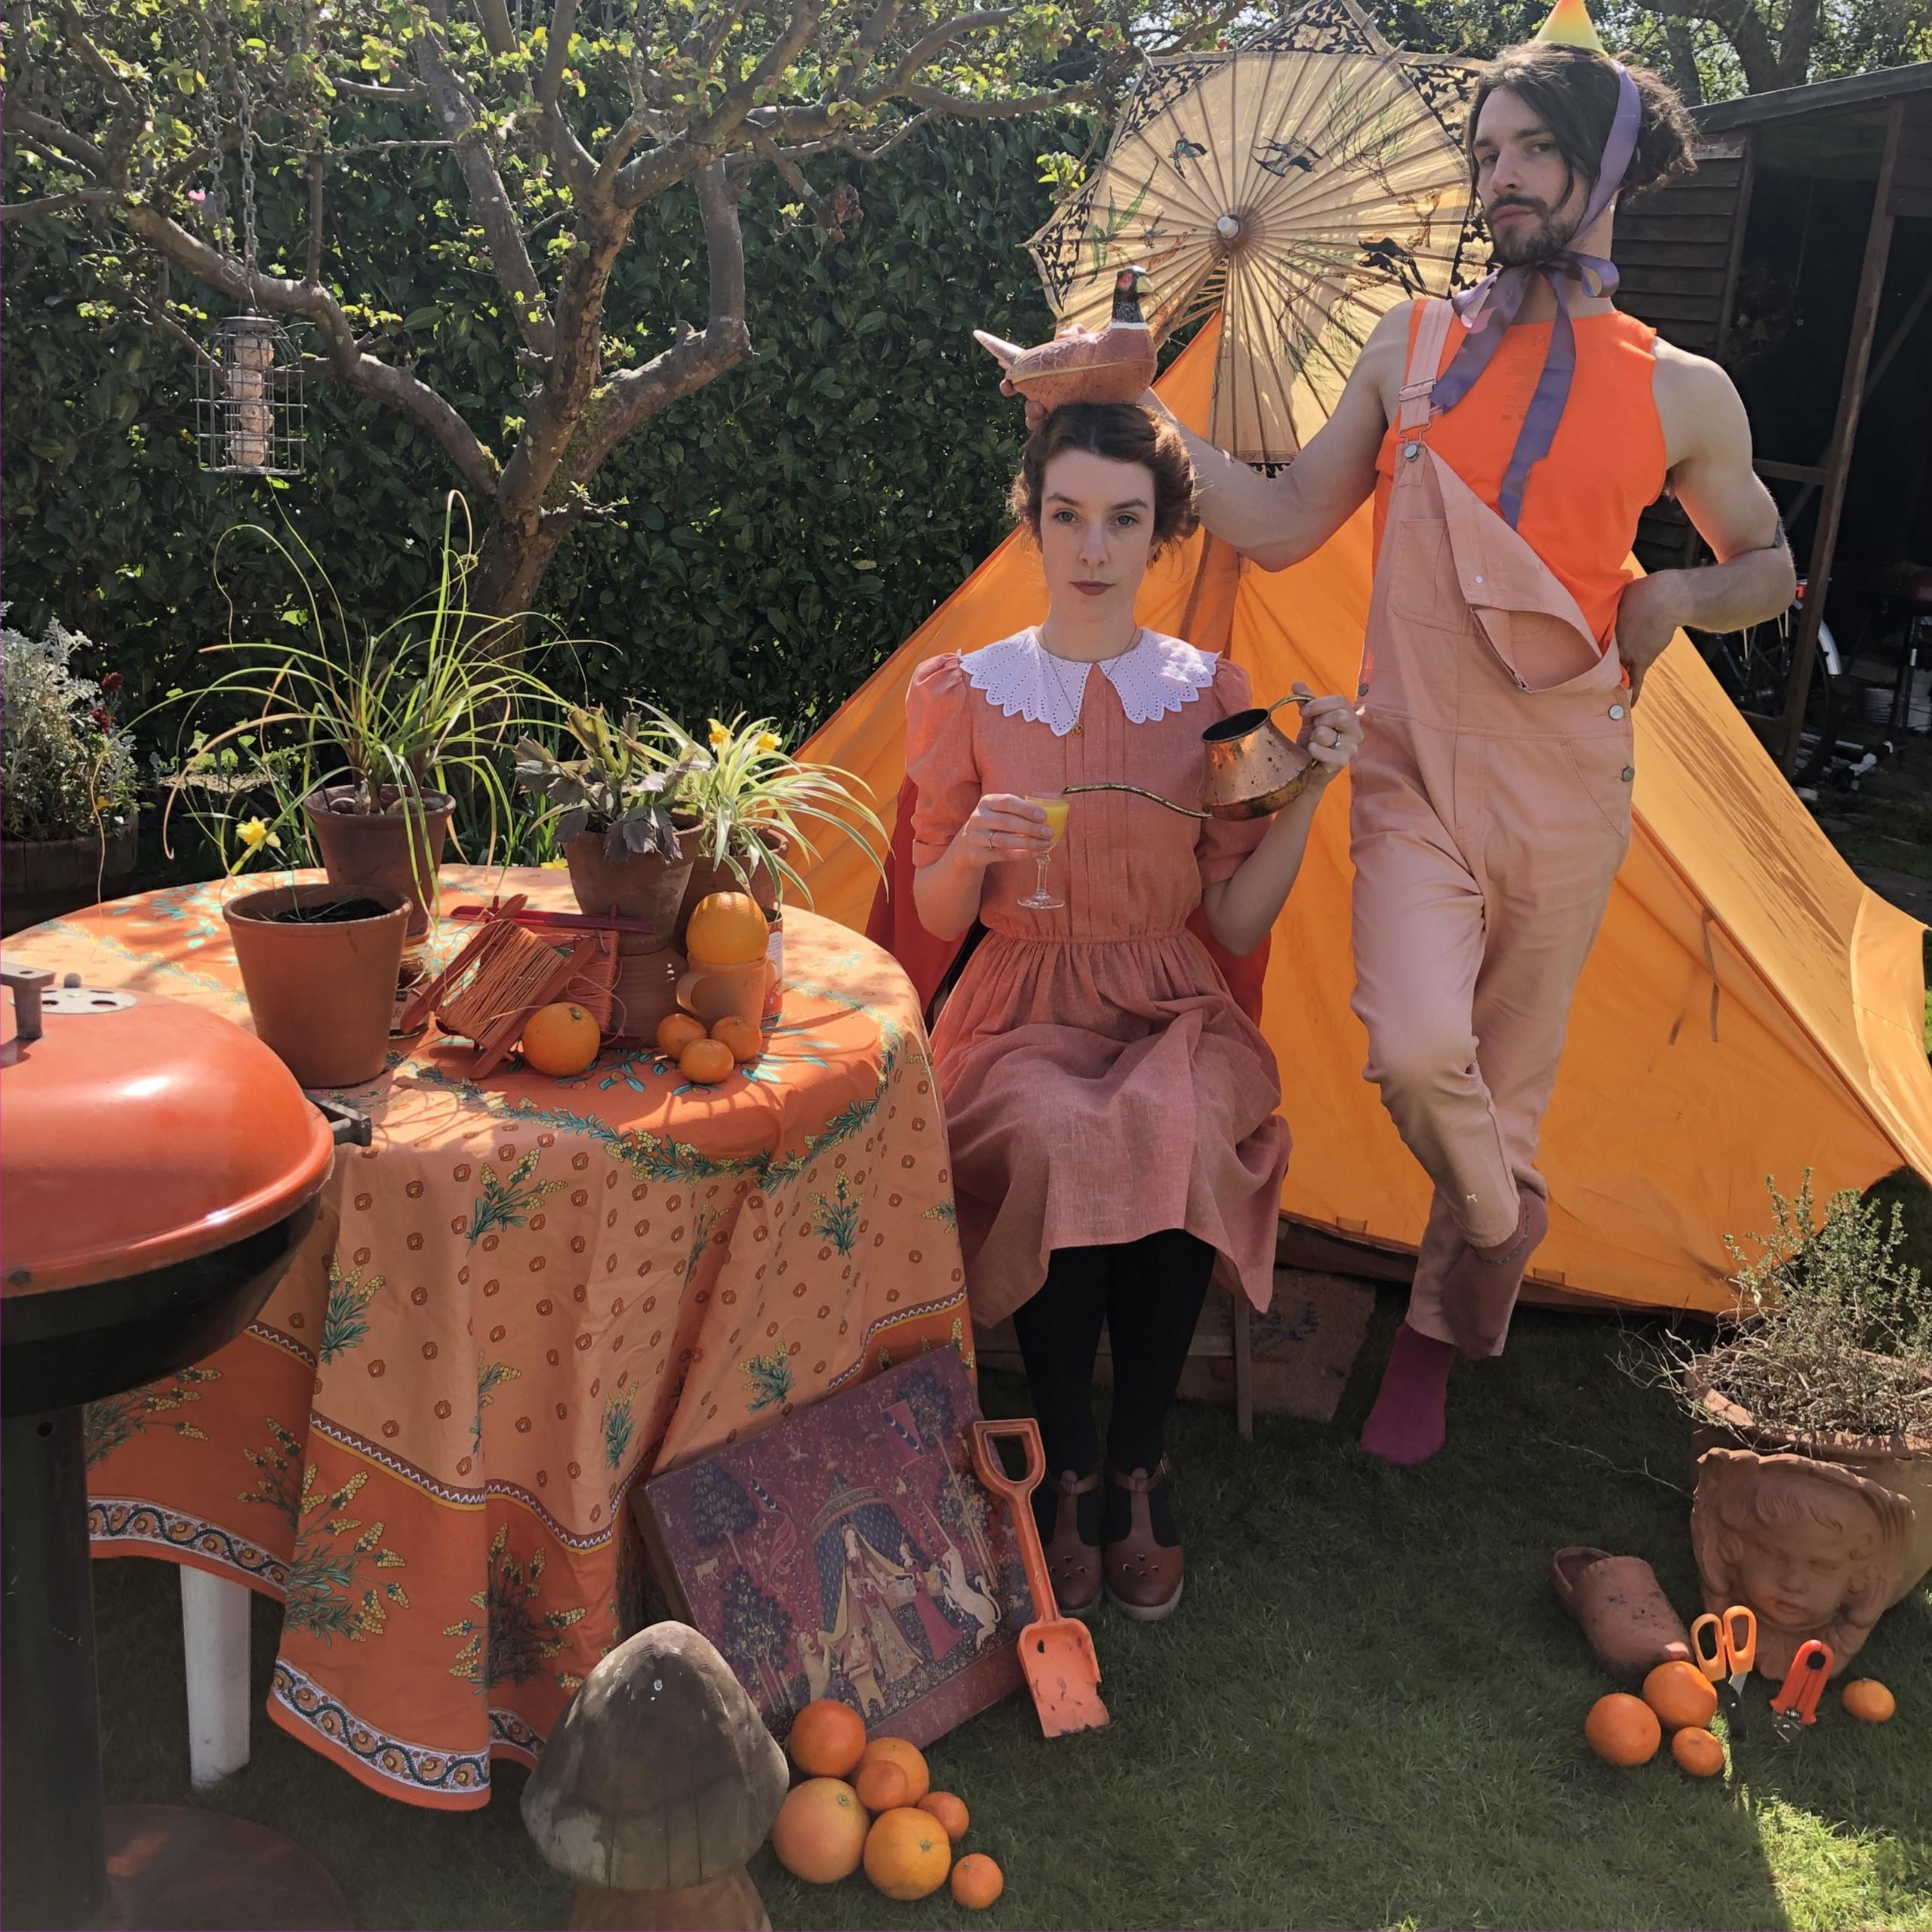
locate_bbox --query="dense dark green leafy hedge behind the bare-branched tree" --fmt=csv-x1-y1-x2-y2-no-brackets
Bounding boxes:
0,122,1074,746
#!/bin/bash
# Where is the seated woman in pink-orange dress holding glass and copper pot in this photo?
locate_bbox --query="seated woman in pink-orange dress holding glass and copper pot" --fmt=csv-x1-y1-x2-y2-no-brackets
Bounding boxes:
906,406,1360,1619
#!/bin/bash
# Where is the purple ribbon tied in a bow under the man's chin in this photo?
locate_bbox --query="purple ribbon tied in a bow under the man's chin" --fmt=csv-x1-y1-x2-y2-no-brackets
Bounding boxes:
1429,62,1642,529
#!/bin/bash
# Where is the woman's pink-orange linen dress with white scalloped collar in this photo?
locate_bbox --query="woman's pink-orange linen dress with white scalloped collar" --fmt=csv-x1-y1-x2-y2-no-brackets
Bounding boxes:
906,630,1289,1325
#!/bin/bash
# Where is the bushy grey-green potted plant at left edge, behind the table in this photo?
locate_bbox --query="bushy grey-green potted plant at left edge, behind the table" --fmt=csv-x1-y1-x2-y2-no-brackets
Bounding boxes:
0,605,139,929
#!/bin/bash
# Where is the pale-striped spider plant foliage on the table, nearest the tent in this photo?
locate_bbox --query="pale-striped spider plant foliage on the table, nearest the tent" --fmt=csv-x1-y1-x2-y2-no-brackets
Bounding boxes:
655,713,887,946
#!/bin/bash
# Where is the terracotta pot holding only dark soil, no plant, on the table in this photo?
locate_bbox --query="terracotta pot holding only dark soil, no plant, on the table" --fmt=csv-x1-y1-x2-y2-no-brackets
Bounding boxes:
222,884,410,1088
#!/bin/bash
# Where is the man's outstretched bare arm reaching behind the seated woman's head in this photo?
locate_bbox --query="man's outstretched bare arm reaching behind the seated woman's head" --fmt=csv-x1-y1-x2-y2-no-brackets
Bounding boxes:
1146,303,1411,570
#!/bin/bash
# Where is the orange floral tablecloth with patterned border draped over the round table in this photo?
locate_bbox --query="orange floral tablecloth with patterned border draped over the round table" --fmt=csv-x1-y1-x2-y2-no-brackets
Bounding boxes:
8,869,972,1808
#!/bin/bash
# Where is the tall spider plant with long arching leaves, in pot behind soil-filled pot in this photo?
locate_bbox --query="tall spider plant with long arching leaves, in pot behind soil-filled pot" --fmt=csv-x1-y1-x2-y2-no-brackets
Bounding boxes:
170,491,562,941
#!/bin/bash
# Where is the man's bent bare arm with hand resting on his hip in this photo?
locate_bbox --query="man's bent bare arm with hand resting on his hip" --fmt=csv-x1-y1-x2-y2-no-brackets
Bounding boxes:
1617,346,1797,700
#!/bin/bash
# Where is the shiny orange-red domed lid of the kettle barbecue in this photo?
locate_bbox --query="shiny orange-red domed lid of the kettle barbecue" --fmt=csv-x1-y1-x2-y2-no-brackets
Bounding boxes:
0,966,334,1297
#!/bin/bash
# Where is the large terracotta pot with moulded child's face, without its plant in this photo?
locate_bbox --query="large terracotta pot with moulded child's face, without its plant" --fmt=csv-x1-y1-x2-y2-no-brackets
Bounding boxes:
1690,1372,1932,1681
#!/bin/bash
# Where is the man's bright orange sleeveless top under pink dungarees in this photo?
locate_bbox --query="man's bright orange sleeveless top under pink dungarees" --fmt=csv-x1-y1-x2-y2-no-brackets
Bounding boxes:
1376,301,1666,645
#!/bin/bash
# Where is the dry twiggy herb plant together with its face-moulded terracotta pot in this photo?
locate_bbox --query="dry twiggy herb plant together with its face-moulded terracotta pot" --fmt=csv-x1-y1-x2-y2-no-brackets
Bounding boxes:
1638,1174,1932,1681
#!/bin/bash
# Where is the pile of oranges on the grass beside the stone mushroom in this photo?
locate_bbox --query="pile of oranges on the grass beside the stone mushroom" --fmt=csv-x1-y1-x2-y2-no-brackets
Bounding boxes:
771,1698,1007,1911
